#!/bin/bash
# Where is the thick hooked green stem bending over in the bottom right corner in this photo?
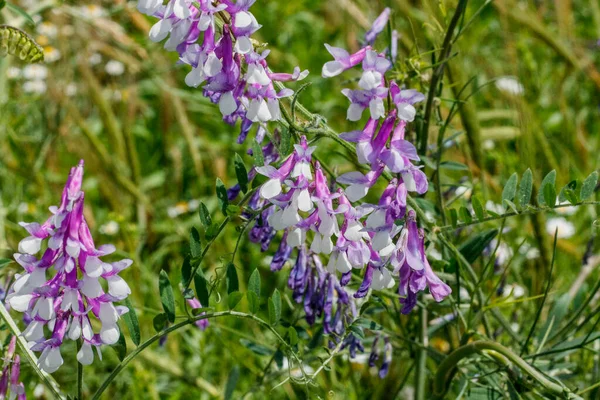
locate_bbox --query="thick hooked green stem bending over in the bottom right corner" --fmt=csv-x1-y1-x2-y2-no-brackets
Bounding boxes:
433,341,573,399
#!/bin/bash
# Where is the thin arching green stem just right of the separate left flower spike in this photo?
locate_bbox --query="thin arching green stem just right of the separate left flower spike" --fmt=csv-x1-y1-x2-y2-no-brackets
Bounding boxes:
92,311,300,400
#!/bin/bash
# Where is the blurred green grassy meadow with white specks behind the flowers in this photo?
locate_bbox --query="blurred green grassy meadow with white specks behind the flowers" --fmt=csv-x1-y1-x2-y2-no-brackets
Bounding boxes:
0,0,600,399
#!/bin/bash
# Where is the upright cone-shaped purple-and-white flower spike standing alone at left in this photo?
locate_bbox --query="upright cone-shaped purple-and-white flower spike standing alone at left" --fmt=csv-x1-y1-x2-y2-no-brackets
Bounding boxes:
6,161,132,373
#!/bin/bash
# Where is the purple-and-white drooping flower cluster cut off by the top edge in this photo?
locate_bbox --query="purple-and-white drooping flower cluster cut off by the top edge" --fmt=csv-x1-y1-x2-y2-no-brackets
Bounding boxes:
138,0,308,141
